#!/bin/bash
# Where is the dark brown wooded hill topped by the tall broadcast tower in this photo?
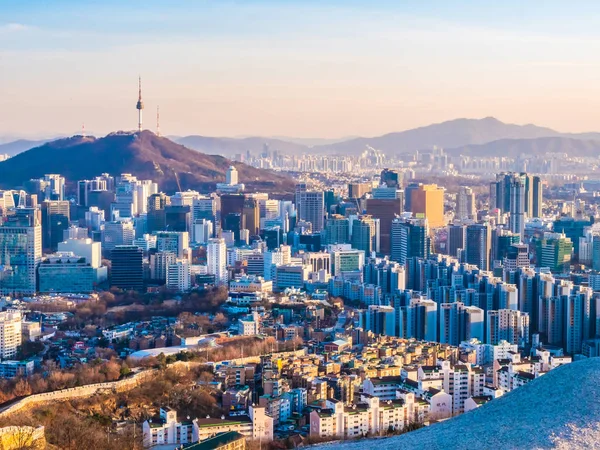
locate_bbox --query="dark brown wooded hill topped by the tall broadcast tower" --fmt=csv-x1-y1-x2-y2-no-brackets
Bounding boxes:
0,131,294,194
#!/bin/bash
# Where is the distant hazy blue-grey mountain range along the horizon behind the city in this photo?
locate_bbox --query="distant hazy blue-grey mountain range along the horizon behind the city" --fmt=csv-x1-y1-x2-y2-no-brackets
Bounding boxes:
0,117,600,158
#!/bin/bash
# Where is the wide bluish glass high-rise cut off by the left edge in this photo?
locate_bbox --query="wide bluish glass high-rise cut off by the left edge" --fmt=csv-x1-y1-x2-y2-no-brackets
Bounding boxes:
0,214,42,295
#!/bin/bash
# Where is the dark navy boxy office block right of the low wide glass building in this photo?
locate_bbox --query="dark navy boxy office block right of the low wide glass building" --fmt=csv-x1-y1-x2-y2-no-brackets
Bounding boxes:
110,245,144,291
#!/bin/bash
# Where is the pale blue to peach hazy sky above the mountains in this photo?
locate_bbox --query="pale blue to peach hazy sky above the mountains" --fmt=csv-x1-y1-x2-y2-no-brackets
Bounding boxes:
0,0,600,137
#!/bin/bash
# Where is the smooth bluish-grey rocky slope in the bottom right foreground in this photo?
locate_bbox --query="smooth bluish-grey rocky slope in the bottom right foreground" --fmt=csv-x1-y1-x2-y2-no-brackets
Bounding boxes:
321,358,600,450
